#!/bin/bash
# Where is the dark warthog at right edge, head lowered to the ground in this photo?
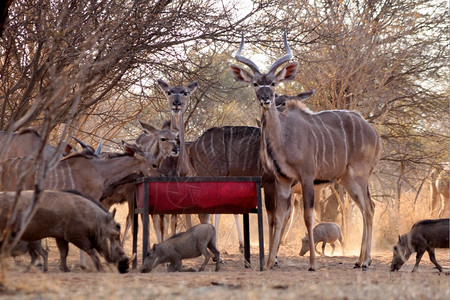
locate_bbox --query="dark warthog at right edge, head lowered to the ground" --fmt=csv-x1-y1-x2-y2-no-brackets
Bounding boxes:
391,219,449,272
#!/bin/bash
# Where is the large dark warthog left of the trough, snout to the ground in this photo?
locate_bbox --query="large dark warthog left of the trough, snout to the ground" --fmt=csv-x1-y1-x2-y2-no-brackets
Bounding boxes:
0,190,129,273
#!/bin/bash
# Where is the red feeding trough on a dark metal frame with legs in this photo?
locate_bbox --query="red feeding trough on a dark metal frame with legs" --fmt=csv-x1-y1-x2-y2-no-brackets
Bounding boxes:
133,177,264,271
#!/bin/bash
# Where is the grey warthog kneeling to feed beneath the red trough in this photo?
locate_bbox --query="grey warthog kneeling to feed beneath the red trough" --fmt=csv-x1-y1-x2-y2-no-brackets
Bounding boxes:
141,224,220,273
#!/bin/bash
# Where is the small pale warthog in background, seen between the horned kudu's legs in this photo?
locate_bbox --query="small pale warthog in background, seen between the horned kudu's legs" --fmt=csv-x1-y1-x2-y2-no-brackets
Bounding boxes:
300,222,345,256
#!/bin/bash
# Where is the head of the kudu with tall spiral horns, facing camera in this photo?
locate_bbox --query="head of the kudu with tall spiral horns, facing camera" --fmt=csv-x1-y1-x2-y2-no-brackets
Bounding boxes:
230,32,298,109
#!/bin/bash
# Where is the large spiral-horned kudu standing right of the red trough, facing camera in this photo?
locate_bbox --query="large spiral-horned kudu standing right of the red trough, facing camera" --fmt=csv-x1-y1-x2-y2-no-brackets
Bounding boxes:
230,34,381,271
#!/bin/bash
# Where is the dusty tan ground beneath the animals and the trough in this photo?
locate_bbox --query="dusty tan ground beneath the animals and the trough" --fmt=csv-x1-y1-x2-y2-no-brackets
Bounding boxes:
0,205,450,300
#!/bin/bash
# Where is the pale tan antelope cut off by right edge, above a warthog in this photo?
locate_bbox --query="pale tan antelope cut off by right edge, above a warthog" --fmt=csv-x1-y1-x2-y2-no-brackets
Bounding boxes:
430,166,450,218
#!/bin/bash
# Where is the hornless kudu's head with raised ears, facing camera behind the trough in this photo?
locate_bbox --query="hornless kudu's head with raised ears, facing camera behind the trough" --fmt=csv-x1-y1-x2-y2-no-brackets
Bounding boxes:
158,79,198,115
